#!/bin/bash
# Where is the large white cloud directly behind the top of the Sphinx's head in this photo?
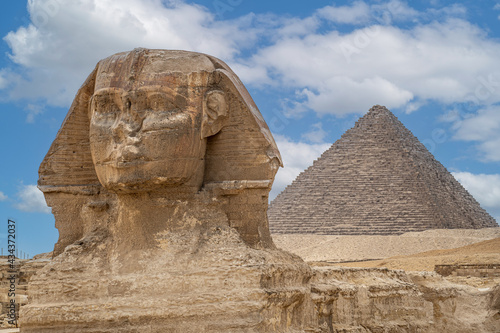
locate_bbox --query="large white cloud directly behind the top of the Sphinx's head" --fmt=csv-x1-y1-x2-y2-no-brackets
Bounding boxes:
0,0,255,106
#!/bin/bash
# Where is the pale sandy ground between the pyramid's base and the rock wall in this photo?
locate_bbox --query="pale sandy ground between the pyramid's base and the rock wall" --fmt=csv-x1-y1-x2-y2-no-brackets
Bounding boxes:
273,228,500,290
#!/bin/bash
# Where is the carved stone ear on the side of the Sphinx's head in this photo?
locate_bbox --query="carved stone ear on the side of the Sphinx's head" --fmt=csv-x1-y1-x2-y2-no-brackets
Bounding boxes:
201,90,228,139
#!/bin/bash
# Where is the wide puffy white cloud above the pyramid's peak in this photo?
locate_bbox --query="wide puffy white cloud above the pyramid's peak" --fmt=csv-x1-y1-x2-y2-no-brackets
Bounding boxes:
249,19,500,115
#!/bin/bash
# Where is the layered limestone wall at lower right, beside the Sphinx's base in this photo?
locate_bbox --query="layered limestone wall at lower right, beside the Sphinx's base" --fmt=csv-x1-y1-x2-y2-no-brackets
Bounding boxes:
311,267,500,333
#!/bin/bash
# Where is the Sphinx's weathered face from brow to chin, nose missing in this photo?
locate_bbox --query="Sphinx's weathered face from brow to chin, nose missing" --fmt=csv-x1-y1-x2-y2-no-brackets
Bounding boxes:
89,69,206,193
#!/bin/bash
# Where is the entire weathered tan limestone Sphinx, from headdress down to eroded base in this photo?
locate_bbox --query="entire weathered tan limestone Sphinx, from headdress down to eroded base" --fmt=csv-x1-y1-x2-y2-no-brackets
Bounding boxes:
21,49,311,333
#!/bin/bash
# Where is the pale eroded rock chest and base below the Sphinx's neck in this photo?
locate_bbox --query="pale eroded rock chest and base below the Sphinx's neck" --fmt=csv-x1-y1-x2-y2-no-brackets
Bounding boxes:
21,227,314,333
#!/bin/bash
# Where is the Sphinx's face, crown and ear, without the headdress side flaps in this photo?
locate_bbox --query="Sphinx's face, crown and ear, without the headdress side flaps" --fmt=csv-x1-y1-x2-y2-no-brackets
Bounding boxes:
89,49,228,193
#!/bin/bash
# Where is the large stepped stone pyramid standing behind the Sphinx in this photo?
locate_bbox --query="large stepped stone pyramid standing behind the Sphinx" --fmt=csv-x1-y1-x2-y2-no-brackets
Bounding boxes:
268,105,498,235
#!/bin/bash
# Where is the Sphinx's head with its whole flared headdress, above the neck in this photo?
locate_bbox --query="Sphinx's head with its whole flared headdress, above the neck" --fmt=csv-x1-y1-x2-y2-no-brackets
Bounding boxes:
38,49,282,254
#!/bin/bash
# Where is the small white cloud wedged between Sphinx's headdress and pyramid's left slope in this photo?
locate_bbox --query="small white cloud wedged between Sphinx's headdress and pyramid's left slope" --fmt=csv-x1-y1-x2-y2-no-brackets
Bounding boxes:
269,135,331,200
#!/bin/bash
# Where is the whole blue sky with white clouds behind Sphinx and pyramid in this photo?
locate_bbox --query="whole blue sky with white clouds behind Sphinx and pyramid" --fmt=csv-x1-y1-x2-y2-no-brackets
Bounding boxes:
0,0,500,254
